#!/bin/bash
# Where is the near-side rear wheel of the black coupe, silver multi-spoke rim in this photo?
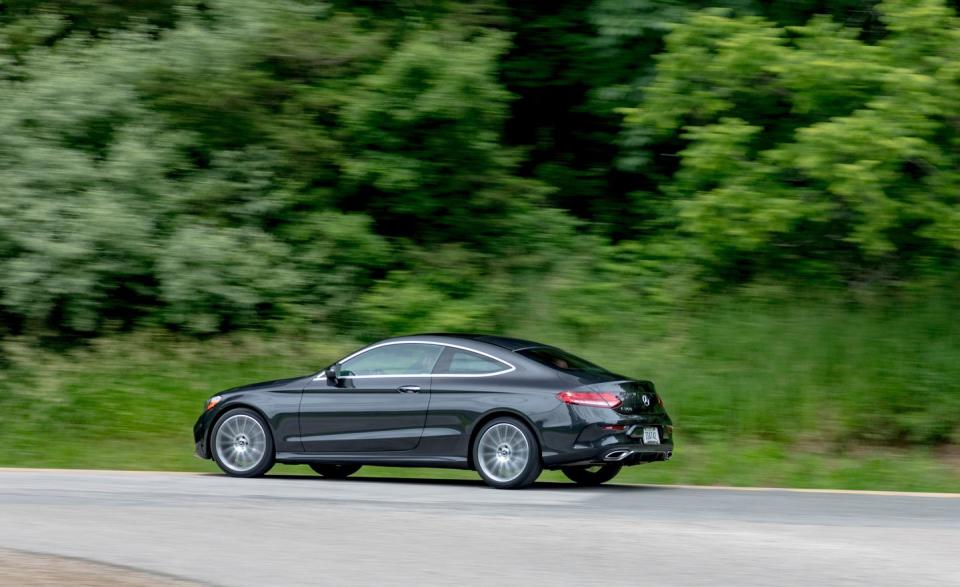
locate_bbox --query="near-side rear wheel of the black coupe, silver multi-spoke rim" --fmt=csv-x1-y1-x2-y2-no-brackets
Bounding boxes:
473,417,543,489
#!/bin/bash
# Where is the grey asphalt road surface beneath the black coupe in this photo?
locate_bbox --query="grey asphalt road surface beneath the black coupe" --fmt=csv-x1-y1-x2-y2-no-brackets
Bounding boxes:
0,470,960,587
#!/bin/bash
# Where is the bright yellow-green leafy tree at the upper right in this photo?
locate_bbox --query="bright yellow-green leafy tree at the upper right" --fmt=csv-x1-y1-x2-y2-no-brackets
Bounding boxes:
627,1,960,276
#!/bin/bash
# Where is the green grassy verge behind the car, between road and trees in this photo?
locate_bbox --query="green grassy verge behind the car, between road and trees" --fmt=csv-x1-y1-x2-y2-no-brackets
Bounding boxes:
0,292,960,491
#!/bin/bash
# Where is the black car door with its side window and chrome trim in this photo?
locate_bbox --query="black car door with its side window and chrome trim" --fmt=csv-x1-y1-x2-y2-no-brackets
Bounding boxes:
300,342,443,453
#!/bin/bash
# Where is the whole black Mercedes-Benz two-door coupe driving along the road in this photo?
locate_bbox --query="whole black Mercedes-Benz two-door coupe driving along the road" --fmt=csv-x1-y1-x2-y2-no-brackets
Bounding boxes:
194,334,673,489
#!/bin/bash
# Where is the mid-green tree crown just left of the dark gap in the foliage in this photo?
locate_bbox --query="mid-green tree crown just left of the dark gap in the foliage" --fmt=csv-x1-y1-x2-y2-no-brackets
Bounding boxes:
343,29,539,245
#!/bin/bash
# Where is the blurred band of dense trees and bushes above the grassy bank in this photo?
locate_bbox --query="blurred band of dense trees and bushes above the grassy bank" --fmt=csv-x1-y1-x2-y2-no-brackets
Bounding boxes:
0,0,960,336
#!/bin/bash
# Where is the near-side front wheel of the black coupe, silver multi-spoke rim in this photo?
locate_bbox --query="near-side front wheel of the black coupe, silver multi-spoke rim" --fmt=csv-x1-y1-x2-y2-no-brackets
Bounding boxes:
210,408,276,477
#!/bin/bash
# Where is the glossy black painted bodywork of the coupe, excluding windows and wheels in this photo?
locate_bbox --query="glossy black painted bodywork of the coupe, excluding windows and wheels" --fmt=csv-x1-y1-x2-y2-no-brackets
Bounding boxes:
194,334,673,468
